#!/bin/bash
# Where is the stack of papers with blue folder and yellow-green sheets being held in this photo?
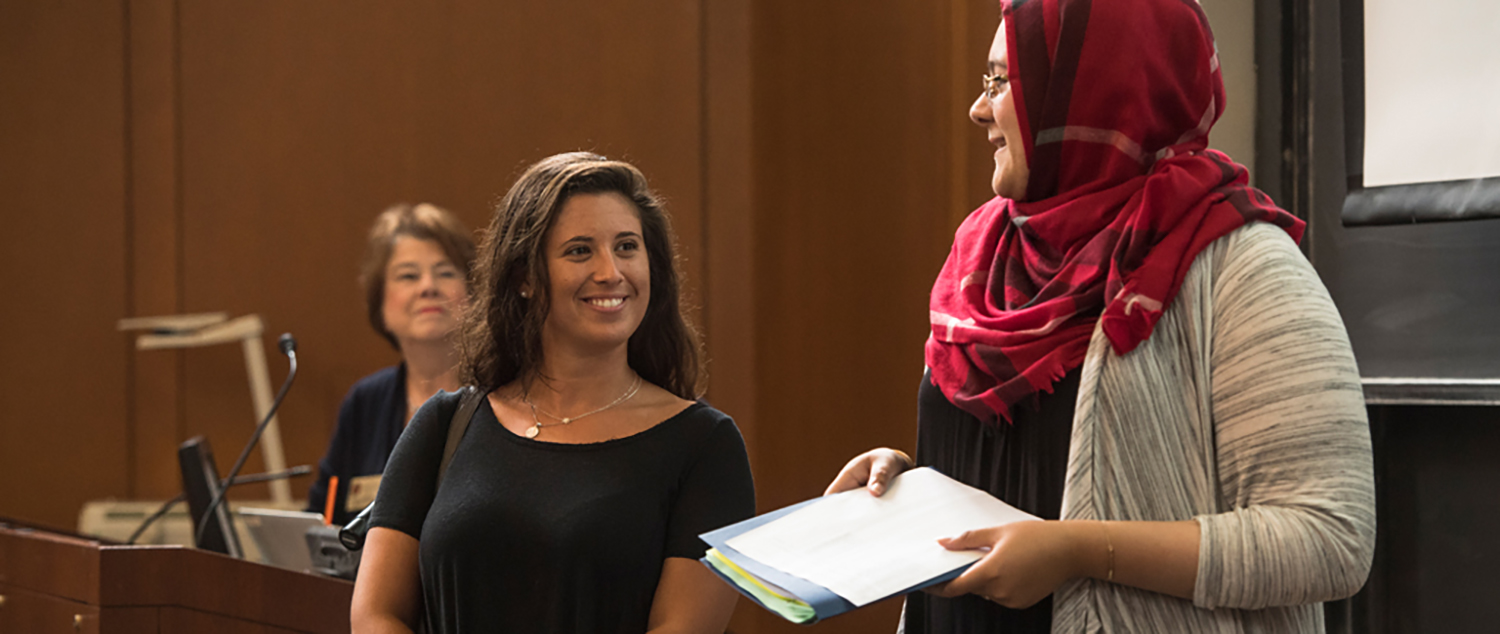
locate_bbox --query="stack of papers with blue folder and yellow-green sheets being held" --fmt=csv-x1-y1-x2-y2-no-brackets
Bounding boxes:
701,468,1037,624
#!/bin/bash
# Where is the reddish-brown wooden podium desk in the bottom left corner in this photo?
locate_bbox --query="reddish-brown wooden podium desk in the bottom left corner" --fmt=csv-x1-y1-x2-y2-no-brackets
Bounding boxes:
0,519,354,634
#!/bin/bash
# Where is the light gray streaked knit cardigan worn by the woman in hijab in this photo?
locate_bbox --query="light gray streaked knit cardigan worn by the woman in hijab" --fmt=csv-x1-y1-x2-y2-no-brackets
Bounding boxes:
1053,223,1376,634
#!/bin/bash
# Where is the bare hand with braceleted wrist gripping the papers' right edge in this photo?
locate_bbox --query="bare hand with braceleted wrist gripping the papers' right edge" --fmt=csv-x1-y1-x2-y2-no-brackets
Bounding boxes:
927,522,1103,609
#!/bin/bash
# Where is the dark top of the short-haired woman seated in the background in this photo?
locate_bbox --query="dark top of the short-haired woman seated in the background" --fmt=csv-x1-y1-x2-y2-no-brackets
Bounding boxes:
308,364,407,526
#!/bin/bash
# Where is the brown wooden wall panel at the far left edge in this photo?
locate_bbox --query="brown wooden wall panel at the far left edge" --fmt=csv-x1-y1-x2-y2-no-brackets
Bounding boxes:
0,1,128,526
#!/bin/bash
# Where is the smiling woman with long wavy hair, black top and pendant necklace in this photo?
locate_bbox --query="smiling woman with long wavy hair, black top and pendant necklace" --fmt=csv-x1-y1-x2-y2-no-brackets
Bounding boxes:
351,153,755,633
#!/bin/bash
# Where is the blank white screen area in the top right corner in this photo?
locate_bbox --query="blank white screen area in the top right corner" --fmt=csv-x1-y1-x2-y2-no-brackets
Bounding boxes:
1368,0,1500,187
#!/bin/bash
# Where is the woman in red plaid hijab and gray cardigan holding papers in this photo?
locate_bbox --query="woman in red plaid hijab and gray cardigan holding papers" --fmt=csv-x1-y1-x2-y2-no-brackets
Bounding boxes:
830,0,1376,634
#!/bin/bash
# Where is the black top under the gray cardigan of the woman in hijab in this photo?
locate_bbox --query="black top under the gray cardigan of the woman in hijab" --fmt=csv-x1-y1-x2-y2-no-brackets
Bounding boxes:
906,369,1082,634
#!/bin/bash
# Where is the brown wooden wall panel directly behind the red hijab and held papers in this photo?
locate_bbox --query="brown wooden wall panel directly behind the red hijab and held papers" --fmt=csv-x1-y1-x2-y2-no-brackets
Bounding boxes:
737,0,998,633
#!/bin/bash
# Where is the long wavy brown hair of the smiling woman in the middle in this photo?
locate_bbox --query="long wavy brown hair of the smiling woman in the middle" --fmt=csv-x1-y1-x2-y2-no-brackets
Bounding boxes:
459,151,704,400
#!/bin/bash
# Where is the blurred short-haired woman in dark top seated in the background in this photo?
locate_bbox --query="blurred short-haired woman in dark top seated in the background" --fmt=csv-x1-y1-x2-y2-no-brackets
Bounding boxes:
308,202,474,525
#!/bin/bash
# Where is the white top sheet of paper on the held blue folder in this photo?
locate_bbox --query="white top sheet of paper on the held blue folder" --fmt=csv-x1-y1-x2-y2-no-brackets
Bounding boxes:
728,468,1037,607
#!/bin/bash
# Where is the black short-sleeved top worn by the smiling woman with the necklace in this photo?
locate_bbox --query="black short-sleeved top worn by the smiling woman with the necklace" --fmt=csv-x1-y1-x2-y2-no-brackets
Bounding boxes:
371,393,755,634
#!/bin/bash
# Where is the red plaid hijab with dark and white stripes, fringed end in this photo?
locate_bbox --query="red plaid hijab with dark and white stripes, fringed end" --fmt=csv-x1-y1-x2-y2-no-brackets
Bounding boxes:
927,0,1304,423
